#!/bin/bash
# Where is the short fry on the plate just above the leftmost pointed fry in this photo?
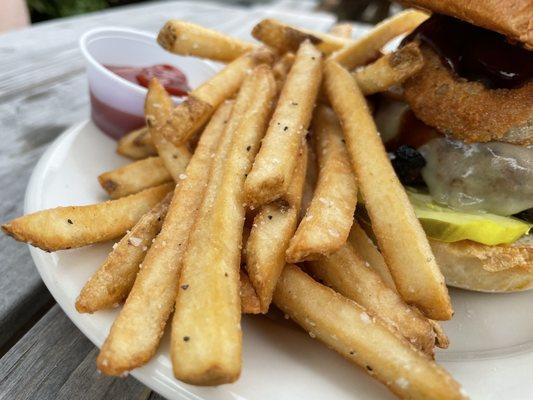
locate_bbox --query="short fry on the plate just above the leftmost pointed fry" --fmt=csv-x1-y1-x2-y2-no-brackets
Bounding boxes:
98,157,174,199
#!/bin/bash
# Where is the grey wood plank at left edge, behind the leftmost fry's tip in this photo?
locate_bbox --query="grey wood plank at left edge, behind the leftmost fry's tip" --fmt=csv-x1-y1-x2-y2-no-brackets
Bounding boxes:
0,76,87,354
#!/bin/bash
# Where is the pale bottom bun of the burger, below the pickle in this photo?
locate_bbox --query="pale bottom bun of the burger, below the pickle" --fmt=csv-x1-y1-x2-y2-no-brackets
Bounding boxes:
429,236,533,293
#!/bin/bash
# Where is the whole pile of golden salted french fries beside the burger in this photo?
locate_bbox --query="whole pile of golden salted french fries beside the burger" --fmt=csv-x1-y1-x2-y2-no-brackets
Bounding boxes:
3,10,466,399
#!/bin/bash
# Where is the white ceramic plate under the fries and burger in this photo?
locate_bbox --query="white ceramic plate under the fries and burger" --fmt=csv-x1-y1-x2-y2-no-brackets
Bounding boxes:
25,122,533,400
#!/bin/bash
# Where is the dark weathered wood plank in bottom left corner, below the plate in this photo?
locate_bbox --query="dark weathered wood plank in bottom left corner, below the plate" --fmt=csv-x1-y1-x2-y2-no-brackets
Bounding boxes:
0,305,151,400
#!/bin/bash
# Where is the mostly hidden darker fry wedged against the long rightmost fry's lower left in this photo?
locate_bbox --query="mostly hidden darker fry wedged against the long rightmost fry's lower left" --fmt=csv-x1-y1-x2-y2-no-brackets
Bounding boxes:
348,221,397,292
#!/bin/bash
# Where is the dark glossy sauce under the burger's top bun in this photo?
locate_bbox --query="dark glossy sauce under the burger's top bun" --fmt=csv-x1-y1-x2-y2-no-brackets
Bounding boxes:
401,14,533,89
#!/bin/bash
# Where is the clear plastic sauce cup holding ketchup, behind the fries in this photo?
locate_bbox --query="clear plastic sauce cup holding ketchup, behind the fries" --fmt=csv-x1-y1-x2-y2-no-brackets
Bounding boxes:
79,27,215,139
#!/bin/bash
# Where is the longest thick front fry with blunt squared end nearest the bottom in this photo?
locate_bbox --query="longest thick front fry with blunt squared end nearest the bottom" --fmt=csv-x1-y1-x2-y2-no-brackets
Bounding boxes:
171,65,276,385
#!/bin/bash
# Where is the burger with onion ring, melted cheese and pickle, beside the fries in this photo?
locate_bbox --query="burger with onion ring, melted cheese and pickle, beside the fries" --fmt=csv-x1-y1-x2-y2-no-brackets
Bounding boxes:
375,0,533,292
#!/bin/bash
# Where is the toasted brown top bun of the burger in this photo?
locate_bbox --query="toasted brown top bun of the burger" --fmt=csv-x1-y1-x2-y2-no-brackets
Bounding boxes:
399,0,533,50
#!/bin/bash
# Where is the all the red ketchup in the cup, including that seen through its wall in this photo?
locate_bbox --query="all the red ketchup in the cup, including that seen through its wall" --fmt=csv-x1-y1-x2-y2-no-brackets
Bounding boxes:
90,64,190,139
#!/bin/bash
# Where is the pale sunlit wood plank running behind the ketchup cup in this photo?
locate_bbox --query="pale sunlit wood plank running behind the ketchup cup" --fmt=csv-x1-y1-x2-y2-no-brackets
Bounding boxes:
0,2,246,101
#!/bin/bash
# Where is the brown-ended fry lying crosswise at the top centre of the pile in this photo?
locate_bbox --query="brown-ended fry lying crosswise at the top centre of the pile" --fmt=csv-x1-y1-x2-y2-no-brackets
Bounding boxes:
252,19,352,54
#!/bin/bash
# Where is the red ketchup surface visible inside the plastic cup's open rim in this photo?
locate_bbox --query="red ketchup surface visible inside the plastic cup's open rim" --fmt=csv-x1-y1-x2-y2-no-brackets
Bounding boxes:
104,64,191,97
